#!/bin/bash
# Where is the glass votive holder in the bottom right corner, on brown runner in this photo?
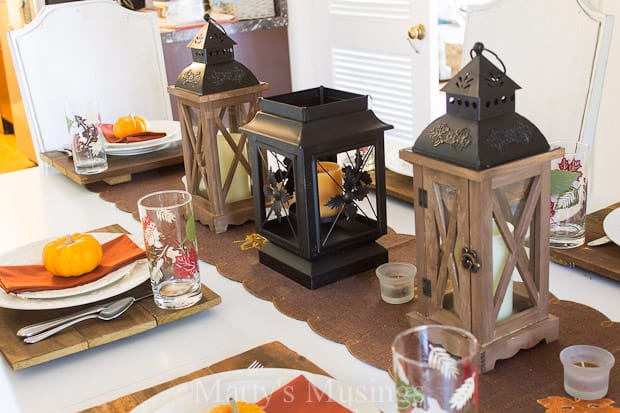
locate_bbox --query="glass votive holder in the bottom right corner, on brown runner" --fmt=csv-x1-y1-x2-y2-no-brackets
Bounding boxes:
560,345,615,400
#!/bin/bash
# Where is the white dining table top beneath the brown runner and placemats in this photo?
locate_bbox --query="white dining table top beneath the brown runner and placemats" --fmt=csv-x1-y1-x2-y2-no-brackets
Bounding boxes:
0,166,620,413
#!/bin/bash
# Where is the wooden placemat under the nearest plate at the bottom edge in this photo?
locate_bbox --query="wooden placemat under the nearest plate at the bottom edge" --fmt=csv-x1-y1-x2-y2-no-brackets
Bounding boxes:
84,341,327,413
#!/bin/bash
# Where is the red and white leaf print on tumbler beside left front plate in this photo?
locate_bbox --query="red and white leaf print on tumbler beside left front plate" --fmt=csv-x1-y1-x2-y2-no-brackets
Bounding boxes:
142,209,198,282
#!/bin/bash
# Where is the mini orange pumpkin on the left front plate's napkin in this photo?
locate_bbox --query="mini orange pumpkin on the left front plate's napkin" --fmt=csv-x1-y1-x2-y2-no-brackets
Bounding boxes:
43,233,103,277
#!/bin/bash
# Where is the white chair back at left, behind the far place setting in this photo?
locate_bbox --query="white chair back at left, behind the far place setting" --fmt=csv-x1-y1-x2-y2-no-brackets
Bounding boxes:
8,0,172,160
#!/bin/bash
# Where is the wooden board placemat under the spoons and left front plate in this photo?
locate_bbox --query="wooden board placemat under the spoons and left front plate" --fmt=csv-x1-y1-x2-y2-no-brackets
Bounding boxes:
0,225,221,370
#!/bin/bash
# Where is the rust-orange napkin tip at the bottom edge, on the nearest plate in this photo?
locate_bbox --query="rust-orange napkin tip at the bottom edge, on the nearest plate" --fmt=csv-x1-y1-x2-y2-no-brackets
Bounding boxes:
256,374,352,413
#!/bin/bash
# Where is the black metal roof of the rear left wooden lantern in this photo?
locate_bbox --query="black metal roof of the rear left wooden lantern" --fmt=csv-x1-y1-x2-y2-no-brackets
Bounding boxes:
175,14,259,95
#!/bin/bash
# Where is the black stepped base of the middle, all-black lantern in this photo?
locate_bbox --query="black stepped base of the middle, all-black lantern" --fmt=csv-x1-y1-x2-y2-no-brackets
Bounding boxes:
258,242,388,290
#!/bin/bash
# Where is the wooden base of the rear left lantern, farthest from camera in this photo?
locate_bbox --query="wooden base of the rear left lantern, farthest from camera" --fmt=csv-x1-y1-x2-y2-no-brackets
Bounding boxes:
192,195,254,234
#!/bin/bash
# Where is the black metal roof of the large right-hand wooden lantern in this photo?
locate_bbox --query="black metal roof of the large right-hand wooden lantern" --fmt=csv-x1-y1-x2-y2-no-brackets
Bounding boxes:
413,43,549,169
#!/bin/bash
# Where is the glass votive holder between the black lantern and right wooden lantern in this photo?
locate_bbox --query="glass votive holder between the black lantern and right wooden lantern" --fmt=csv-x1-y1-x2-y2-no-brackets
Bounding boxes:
376,262,418,304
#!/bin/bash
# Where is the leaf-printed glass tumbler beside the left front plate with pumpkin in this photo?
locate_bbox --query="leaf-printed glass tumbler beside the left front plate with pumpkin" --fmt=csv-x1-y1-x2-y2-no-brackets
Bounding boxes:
138,190,202,310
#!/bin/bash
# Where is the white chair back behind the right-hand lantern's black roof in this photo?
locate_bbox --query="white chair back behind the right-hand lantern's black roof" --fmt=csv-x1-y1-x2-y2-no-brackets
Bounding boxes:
463,0,613,148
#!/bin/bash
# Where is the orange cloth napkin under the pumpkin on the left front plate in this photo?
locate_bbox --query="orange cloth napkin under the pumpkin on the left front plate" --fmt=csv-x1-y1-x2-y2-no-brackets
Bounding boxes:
0,234,145,293
